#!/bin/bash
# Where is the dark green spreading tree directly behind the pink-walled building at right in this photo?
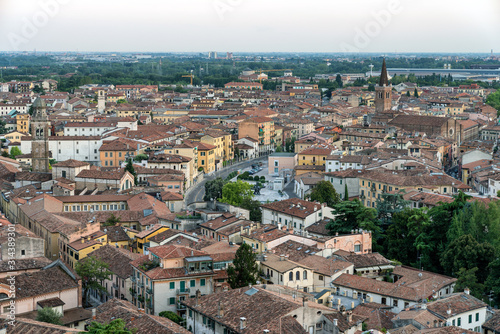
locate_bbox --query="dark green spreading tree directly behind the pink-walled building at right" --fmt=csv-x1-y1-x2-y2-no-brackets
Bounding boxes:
326,199,380,236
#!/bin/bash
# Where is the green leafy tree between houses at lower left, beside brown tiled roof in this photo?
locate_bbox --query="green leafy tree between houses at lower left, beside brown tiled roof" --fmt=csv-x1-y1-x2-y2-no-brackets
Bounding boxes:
75,255,113,305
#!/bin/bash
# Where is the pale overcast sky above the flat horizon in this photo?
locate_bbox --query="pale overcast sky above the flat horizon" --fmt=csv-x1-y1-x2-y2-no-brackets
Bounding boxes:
0,0,500,54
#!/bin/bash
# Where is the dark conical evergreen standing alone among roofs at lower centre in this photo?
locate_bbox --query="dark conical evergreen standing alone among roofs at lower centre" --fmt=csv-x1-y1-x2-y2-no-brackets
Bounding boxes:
227,243,259,289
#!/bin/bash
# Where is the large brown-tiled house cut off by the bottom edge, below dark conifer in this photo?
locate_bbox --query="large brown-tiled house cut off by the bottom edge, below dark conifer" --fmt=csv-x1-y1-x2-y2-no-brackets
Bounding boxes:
182,285,350,334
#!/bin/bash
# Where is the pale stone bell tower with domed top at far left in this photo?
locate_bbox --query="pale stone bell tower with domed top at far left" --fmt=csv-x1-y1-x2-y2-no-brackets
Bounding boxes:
31,98,50,173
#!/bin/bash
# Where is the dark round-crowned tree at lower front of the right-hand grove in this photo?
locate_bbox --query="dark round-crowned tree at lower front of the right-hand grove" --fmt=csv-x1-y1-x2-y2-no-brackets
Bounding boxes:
441,234,495,282
